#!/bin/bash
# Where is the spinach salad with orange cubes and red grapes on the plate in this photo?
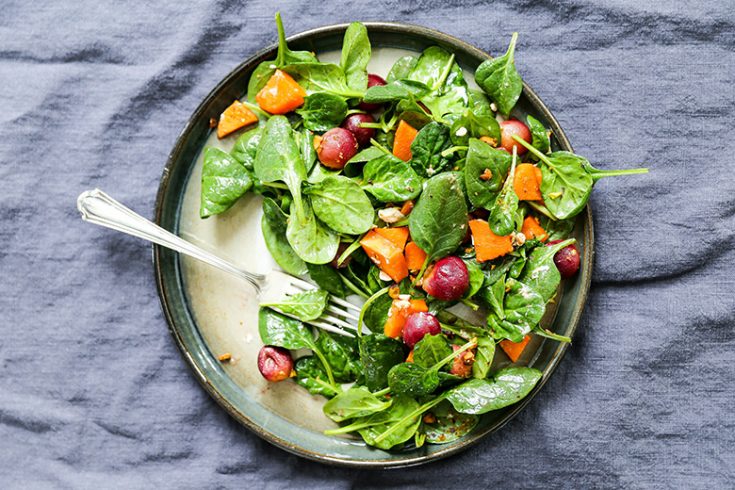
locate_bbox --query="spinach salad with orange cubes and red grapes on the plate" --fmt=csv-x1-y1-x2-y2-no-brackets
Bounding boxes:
200,14,646,449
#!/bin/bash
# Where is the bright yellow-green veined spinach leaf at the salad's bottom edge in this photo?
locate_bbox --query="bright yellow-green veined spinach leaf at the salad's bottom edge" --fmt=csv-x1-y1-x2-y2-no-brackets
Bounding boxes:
358,396,421,450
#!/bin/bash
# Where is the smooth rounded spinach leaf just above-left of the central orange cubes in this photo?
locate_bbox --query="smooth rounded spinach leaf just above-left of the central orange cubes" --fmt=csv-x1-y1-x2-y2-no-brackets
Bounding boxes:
305,176,375,235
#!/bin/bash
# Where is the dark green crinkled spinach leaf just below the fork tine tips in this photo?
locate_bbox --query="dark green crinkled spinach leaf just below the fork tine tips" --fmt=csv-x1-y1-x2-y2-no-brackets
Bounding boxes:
359,333,405,391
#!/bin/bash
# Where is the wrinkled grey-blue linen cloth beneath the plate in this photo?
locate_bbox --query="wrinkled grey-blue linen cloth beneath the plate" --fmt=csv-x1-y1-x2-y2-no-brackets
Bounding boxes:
0,0,735,489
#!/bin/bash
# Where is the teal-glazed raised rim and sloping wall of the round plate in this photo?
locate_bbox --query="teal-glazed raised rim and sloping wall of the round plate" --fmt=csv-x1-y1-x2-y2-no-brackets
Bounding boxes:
153,22,594,468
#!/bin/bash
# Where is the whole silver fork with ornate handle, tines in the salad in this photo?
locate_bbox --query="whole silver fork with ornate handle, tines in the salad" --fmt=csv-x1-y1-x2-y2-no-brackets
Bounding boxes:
77,189,360,337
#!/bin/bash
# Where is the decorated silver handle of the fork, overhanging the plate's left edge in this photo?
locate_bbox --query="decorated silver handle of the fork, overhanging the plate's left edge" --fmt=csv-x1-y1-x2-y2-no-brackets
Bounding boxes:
77,189,264,293
